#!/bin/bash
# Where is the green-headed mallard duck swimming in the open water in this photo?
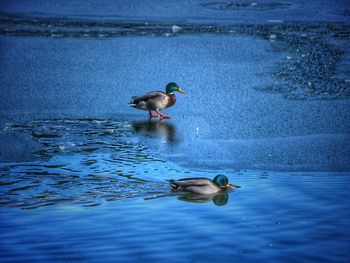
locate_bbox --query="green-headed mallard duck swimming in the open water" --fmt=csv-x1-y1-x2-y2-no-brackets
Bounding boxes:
169,174,239,194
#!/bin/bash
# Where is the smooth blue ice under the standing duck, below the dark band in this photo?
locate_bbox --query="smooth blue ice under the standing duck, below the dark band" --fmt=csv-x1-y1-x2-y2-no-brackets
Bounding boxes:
0,30,350,170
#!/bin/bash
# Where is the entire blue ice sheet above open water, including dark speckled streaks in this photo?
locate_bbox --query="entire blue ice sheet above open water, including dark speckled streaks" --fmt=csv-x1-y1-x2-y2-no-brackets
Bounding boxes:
0,0,350,171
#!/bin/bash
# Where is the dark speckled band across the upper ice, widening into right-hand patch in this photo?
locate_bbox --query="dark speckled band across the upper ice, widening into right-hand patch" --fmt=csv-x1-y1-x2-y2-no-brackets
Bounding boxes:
0,12,350,100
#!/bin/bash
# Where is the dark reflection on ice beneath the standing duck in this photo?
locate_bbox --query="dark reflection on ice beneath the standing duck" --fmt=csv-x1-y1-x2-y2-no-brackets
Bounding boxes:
132,119,177,144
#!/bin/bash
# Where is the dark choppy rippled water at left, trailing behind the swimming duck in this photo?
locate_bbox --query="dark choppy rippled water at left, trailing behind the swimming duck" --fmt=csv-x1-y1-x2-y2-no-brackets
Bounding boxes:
0,119,228,209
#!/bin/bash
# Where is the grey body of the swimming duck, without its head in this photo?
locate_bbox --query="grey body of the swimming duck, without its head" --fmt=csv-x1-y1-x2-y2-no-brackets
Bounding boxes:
169,178,222,194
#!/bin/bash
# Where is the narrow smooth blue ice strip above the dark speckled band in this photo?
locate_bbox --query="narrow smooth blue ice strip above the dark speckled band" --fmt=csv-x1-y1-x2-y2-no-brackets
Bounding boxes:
0,0,349,23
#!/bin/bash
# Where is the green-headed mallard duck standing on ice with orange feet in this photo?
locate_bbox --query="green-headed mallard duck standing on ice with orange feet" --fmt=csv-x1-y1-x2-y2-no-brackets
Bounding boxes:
129,82,185,119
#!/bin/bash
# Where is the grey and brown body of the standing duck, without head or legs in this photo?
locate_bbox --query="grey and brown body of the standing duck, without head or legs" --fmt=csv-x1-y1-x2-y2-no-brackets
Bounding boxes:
129,91,176,111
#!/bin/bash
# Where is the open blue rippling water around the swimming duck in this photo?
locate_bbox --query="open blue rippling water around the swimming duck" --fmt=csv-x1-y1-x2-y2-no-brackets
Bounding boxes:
0,119,350,262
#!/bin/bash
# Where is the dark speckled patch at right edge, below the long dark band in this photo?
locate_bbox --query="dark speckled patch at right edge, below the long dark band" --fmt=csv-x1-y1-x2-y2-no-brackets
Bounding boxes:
257,34,350,99
